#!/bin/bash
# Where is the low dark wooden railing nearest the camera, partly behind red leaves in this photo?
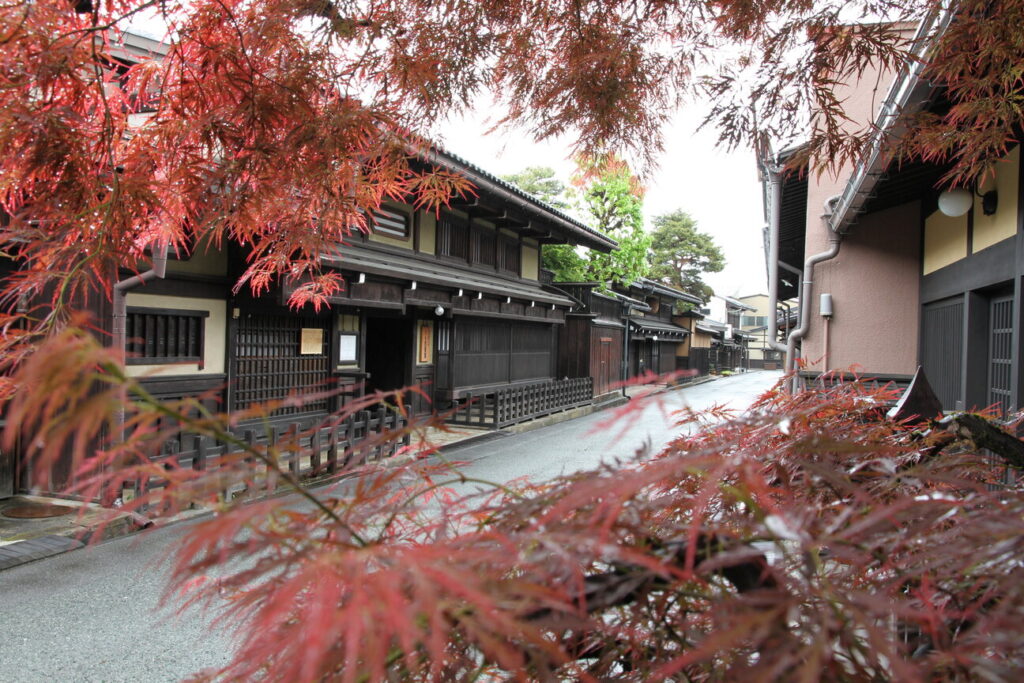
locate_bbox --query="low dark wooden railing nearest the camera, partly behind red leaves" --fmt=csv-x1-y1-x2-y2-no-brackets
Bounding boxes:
135,405,411,494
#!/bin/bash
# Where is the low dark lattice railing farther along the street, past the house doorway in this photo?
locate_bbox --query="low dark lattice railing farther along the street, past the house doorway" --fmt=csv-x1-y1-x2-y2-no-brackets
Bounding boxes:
449,377,594,429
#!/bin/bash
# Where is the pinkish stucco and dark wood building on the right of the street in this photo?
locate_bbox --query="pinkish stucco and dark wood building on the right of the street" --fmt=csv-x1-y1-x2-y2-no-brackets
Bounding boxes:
766,13,1024,413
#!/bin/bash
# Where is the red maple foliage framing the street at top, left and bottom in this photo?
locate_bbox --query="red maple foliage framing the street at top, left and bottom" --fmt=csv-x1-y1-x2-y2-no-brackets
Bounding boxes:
0,0,1024,680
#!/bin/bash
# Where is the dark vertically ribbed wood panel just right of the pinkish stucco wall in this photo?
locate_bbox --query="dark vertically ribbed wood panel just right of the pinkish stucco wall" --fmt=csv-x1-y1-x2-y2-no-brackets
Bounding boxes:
921,297,964,411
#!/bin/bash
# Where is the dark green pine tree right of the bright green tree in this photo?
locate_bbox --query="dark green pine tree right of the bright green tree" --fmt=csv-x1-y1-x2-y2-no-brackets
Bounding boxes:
650,209,725,301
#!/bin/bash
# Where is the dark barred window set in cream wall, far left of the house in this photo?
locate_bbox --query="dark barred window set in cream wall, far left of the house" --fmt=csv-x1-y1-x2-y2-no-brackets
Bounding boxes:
125,308,210,369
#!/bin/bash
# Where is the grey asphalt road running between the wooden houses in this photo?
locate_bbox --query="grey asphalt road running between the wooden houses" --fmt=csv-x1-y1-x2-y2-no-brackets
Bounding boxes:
0,372,779,683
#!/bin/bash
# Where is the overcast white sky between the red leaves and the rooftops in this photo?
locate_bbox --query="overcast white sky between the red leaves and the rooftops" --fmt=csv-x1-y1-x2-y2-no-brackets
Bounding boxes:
438,109,767,296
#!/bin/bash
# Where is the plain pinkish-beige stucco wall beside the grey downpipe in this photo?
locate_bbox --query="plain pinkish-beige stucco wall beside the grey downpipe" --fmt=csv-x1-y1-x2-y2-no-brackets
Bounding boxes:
803,198,921,375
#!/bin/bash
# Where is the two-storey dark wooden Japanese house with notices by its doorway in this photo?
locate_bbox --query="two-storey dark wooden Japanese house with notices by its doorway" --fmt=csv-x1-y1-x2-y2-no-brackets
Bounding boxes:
121,152,614,432
